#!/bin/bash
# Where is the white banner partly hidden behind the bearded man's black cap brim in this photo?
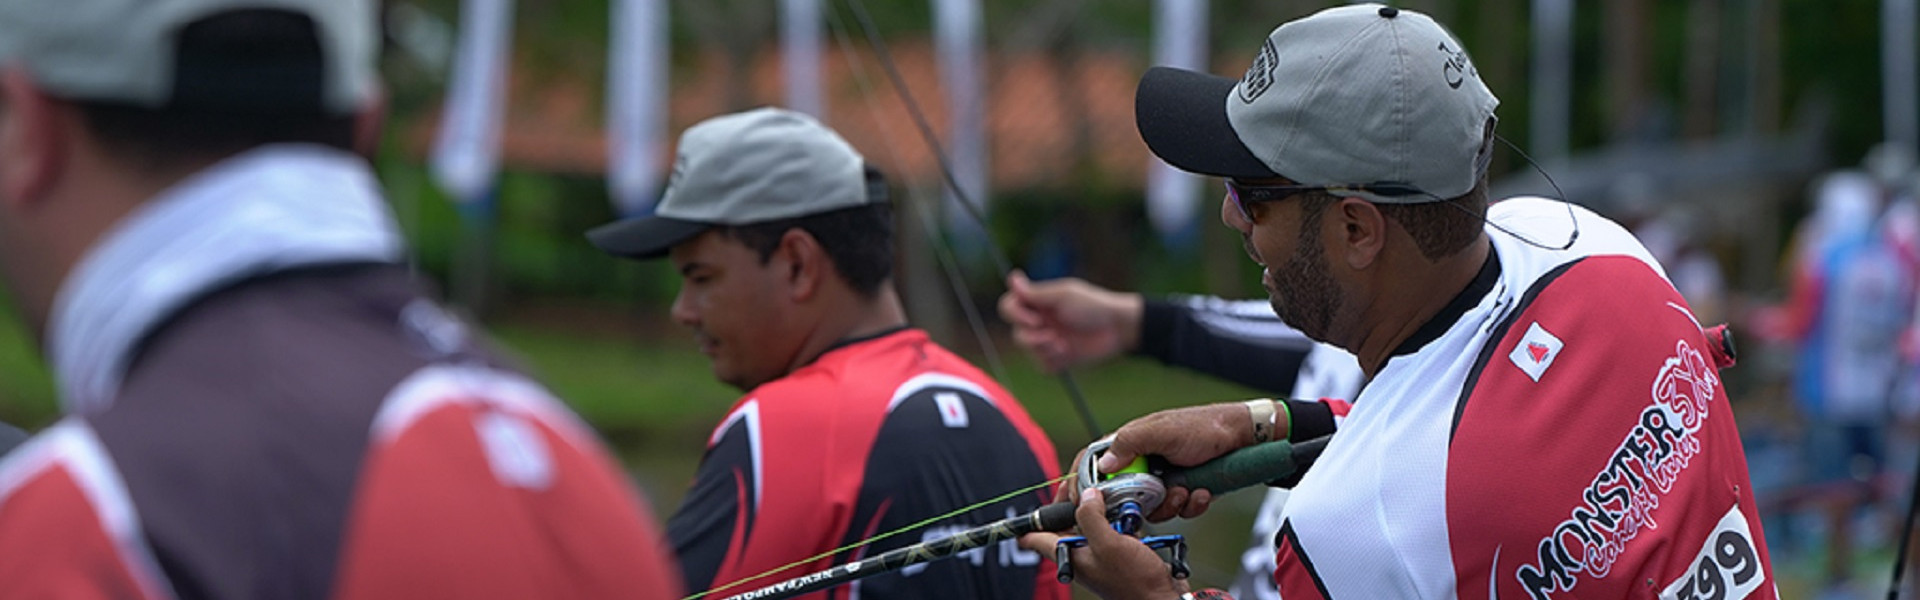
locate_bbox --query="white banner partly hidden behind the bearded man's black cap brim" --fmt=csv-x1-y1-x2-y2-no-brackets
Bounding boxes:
1146,0,1208,240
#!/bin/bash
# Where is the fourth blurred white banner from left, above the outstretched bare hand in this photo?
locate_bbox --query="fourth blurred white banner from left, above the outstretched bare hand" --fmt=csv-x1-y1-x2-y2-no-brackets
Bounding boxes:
933,0,991,233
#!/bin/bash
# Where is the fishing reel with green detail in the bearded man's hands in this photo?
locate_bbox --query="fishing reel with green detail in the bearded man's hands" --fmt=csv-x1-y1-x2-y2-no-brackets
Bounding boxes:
1054,437,1190,583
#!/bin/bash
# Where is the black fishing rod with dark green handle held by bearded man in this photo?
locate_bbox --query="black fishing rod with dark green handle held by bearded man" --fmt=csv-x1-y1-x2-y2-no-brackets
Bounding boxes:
724,437,1329,600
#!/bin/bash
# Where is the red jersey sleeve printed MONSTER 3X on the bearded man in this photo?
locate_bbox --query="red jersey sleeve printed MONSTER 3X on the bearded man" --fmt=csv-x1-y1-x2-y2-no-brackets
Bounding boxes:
1446,256,1776,598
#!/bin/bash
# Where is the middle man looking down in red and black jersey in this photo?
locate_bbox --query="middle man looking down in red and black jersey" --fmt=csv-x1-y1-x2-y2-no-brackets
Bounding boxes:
588,108,1068,598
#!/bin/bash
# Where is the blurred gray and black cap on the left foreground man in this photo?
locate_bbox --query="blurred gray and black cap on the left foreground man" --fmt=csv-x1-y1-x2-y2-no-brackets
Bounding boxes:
0,0,380,113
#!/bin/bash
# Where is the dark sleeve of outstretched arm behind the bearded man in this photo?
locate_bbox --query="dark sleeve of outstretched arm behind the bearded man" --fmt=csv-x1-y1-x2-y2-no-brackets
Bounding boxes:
1135,298,1311,396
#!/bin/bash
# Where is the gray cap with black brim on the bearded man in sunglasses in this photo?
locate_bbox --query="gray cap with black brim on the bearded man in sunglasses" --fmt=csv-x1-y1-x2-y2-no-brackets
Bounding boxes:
1135,4,1500,204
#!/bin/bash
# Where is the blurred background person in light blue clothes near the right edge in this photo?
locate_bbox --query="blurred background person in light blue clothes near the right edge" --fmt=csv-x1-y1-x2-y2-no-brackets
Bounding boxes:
1788,158,1914,598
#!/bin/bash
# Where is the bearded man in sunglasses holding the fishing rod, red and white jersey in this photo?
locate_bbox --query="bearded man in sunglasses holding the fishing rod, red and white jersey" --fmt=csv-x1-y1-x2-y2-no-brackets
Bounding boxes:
1023,4,1776,600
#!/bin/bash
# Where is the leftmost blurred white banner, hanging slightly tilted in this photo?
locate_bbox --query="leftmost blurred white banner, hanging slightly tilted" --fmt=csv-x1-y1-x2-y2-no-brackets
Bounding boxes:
430,0,513,202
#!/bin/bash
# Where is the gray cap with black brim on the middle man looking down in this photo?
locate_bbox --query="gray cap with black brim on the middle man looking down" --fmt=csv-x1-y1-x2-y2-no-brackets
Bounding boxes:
588,108,887,258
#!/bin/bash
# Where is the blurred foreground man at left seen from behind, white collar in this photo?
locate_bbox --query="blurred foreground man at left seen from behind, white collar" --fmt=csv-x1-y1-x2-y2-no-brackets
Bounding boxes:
0,0,680,598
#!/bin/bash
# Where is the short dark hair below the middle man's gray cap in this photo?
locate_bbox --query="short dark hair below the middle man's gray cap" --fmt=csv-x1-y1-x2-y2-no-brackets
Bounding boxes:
722,169,893,298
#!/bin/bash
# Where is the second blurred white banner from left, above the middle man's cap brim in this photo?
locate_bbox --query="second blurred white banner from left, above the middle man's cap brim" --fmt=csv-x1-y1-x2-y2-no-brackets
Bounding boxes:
607,0,683,217
